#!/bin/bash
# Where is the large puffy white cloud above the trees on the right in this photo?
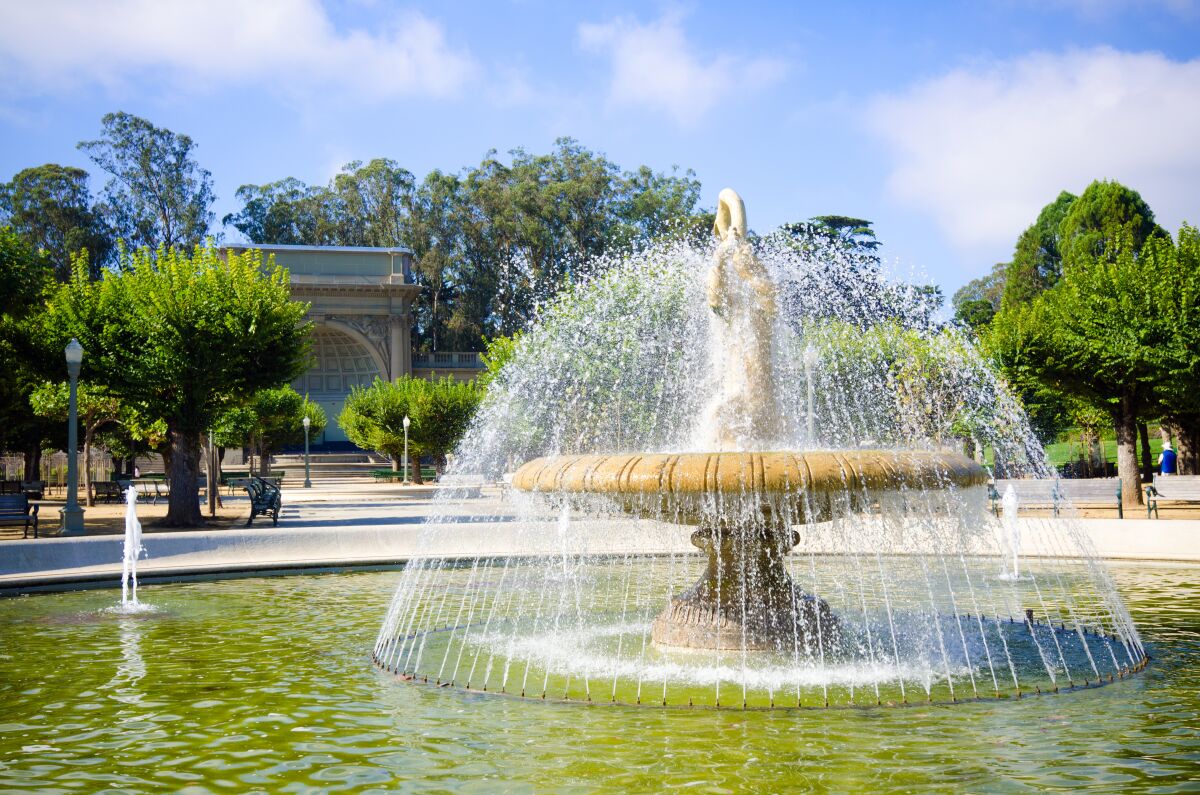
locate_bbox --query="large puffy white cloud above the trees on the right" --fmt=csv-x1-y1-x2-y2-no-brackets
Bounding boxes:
869,48,1200,246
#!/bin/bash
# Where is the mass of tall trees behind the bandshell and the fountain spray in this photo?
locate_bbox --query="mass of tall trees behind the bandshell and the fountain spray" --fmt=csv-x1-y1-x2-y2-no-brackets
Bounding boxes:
224,138,712,351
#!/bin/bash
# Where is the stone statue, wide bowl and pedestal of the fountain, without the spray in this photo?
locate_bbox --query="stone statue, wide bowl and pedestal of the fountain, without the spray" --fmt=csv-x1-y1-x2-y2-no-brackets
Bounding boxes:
512,189,988,650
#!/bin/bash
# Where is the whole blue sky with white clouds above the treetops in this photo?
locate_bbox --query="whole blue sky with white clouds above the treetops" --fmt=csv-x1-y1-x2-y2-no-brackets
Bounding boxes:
0,0,1200,297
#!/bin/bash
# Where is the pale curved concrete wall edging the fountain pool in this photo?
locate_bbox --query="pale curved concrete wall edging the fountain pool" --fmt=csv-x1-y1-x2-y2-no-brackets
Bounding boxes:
0,518,1200,596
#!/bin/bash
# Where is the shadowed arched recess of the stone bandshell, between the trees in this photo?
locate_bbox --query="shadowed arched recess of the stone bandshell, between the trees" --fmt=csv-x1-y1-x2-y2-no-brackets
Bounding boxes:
293,325,384,444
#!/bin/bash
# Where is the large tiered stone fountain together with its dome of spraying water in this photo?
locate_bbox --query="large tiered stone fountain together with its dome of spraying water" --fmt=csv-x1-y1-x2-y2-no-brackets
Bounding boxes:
373,190,1146,707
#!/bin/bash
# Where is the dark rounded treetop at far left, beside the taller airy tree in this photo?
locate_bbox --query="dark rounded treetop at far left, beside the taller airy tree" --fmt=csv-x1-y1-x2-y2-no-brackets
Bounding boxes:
0,163,114,281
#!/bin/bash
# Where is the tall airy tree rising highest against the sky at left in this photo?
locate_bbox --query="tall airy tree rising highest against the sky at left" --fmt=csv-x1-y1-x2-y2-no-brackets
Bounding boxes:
79,112,215,249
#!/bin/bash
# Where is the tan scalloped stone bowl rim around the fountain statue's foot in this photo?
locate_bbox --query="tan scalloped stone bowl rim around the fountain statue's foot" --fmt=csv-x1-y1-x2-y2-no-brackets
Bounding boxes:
512,449,989,496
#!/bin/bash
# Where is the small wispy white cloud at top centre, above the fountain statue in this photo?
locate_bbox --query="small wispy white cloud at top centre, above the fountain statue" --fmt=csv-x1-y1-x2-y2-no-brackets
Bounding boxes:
578,13,786,126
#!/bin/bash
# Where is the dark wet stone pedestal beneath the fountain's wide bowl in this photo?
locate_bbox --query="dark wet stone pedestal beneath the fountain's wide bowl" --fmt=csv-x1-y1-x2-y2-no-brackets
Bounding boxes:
650,522,839,652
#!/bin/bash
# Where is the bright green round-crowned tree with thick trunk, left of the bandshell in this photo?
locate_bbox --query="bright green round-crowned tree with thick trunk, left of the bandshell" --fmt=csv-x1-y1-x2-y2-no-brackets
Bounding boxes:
50,247,311,526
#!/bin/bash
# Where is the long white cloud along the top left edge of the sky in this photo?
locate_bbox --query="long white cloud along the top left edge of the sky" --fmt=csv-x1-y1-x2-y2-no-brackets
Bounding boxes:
0,0,475,98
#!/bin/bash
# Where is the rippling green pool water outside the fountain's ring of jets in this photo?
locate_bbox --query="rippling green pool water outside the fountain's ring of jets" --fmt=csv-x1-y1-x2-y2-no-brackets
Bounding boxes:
0,564,1200,793
